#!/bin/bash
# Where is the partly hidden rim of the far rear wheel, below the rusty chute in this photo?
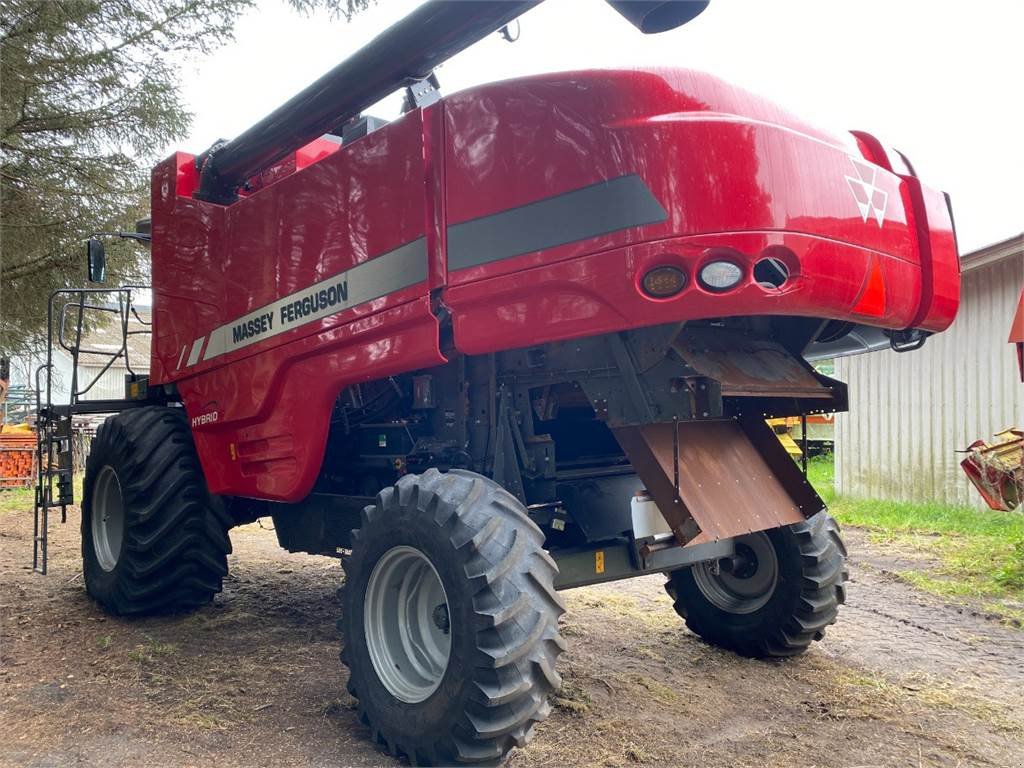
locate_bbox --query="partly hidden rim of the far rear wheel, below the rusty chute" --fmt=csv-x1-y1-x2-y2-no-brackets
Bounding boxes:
693,532,778,613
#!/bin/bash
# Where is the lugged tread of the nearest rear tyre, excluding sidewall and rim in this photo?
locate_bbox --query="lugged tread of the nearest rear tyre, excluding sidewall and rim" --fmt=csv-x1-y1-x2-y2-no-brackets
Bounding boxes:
340,469,565,765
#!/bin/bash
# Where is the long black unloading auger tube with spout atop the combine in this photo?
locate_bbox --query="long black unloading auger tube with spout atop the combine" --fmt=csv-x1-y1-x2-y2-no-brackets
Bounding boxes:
196,0,708,204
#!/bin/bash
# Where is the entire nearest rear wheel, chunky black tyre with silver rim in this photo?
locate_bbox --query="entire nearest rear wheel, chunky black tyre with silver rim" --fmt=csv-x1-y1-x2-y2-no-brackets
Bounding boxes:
338,469,565,765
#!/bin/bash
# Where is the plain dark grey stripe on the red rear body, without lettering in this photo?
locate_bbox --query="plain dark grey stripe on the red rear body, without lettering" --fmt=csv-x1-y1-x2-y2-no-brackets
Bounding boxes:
447,173,669,270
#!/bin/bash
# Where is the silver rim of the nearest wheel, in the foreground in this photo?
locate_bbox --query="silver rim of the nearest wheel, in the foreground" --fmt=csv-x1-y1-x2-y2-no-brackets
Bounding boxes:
364,546,452,703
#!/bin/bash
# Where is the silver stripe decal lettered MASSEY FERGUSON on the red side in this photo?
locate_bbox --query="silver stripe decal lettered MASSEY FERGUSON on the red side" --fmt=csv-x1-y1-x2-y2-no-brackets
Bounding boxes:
195,238,427,366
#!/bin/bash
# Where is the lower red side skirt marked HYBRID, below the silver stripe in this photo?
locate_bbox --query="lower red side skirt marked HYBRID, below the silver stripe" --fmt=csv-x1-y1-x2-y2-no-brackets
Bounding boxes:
178,298,444,502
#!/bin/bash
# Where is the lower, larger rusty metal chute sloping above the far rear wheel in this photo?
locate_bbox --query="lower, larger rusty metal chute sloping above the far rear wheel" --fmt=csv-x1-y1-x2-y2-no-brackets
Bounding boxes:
614,419,820,544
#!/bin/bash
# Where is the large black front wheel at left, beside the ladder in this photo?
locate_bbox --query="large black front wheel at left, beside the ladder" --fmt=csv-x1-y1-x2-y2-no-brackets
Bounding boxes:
82,407,231,614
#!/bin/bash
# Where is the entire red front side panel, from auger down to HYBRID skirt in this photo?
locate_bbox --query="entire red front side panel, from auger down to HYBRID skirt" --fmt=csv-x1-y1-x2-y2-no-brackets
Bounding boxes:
154,111,444,501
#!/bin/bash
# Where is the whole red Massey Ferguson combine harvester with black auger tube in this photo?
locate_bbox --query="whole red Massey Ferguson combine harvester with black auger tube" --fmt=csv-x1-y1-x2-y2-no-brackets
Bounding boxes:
37,1,959,764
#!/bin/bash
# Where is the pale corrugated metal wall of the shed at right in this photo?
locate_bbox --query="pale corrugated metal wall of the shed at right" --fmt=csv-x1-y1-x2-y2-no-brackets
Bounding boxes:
836,253,1024,507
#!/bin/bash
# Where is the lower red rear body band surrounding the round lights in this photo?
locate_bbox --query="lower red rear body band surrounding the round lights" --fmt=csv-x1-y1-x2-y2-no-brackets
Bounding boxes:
445,232,921,354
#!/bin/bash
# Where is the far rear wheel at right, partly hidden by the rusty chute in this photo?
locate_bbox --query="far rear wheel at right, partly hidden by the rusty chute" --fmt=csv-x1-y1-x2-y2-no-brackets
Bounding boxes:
665,511,848,657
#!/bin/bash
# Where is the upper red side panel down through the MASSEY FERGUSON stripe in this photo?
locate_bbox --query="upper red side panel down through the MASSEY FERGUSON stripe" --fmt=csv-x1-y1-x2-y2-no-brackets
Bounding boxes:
153,111,427,381
